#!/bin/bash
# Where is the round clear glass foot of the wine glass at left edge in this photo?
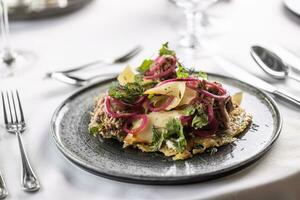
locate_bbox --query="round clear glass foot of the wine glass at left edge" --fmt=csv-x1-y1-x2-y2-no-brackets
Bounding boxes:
0,50,36,78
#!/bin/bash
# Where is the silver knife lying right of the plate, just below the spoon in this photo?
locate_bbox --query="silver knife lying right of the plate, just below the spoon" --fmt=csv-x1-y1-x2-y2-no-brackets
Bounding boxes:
214,57,300,106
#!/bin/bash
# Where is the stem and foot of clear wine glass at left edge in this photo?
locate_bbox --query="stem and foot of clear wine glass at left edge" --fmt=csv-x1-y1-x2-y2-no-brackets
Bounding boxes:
0,0,36,78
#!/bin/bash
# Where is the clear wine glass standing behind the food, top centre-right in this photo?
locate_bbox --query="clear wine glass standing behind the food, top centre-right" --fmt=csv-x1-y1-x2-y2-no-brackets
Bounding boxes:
172,0,218,57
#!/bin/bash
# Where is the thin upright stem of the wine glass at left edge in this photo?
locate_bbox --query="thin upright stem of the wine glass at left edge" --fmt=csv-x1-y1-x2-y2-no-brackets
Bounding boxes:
0,0,14,63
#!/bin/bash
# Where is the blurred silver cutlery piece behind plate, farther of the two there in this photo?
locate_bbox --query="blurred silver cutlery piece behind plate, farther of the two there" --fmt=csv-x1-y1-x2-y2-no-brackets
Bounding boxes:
46,46,142,78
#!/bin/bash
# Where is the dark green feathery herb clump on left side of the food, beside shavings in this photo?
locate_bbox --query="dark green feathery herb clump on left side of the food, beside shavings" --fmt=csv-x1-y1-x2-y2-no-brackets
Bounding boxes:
108,82,144,103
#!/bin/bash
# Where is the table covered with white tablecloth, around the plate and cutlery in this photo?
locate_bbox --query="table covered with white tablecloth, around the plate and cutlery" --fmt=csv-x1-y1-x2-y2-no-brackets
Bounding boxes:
0,0,300,200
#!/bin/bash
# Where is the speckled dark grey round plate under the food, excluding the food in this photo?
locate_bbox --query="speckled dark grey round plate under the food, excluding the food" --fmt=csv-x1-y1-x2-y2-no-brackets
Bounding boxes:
51,74,282,184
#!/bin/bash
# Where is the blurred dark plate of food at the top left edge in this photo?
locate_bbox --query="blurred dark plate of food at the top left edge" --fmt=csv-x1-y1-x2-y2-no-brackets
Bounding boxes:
7,0,92,19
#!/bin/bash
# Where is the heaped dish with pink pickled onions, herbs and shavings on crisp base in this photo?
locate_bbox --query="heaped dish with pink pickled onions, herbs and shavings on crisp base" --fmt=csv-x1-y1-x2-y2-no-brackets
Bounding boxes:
89,43,252,160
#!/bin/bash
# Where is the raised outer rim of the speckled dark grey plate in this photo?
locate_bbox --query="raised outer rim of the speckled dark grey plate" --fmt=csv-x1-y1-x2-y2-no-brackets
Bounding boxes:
50,73,283,185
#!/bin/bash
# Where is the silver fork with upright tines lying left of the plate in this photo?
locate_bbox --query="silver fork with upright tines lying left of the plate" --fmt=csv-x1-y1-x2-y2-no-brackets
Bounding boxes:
1,90,40,192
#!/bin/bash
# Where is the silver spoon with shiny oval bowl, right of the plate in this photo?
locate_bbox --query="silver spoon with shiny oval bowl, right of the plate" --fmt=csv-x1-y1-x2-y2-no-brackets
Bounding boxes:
250,46,300,82
